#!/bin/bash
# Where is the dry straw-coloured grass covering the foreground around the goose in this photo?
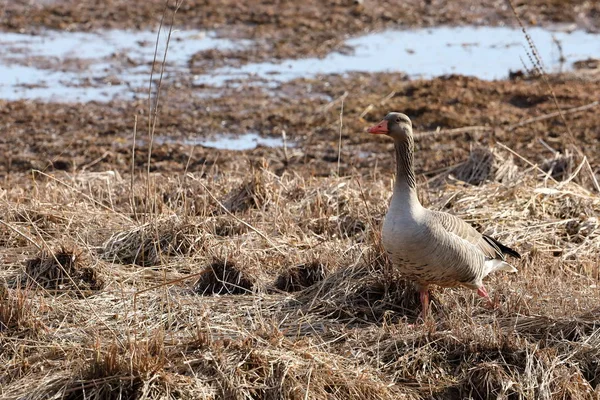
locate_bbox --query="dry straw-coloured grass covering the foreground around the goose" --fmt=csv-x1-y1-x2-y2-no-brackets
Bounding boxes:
0,146,600,400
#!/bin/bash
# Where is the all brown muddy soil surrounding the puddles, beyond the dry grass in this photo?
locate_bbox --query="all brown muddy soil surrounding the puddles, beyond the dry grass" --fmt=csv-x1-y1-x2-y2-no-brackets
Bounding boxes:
0,0,600,184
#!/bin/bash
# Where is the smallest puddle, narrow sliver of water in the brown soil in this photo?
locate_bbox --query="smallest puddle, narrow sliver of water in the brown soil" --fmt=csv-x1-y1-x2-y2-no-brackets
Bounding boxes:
156,132,286,150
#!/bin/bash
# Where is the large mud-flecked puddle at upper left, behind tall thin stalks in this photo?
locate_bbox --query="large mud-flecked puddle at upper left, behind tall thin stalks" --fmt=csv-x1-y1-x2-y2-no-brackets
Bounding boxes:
0,30,244,101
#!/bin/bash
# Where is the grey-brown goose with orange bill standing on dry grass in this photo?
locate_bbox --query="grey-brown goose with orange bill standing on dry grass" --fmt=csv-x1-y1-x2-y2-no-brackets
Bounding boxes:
368,112,521,319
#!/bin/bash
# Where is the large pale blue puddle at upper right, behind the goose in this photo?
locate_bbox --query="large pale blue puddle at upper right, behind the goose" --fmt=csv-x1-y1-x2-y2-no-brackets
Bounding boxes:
196,27,600,85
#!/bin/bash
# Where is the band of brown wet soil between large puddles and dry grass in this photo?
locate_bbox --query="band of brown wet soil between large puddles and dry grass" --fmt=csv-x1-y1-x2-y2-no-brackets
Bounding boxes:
0,73,600,184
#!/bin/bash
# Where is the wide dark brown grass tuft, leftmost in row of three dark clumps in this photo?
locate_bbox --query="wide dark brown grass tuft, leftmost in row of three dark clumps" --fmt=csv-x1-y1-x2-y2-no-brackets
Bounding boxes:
25,246,104,294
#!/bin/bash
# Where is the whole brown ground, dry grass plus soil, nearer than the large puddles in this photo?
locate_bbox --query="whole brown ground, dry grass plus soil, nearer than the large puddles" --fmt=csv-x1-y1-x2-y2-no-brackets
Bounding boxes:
0,2,600,400
